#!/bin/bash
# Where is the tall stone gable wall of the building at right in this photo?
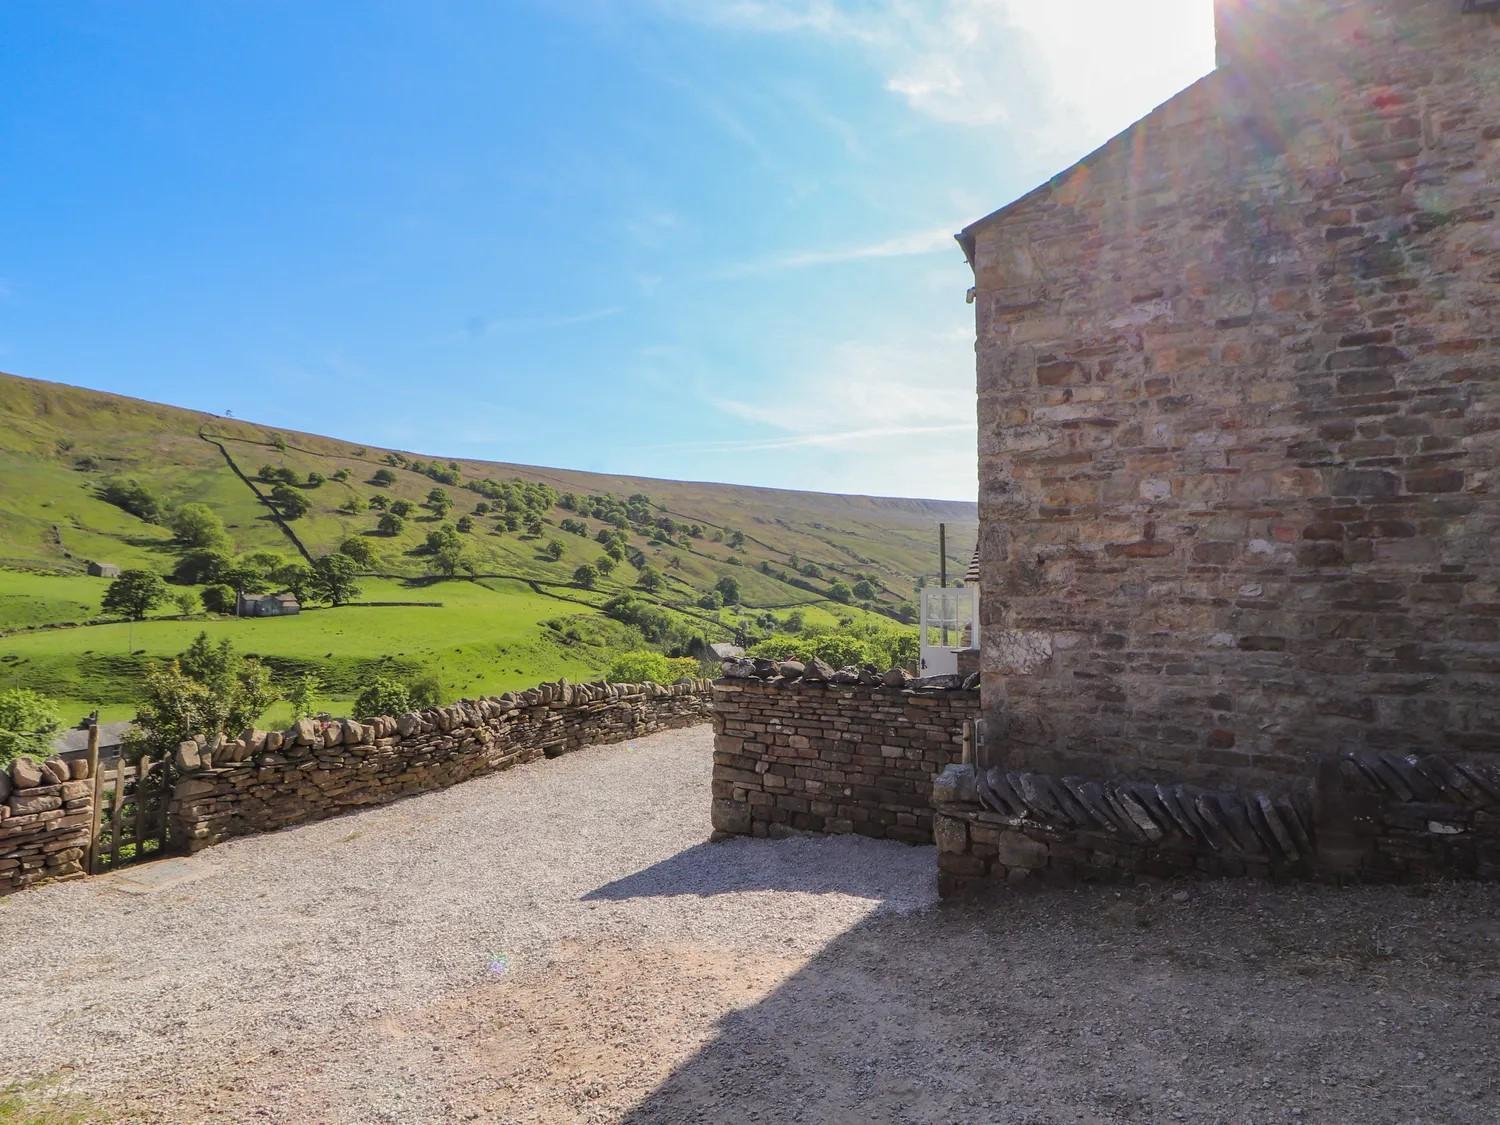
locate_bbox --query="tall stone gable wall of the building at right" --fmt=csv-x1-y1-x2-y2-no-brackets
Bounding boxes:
960,0,1500,789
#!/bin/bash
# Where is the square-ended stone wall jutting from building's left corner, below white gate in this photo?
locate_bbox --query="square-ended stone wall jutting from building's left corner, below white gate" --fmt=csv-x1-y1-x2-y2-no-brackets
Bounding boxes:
713,665,980,843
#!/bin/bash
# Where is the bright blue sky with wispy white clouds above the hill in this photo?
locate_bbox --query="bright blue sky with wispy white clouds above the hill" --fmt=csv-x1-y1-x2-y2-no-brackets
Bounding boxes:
0,0,1212,500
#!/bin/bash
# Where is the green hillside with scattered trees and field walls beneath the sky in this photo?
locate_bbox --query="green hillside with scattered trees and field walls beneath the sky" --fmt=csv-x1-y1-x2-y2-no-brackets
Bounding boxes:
0,375,977,714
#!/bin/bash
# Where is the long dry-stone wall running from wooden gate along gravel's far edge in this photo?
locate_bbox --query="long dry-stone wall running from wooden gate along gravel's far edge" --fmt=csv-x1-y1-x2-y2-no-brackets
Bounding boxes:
171,680,710,852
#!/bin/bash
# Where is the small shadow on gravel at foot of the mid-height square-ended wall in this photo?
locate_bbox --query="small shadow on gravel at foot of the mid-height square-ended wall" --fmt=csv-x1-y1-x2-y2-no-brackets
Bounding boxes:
582,836,936,905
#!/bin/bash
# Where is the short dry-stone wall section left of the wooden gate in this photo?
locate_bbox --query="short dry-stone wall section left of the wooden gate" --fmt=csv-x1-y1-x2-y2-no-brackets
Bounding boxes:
0,758,93,896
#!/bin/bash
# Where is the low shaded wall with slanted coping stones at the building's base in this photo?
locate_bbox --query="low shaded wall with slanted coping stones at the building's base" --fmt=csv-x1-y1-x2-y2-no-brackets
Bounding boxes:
933,752,1500,894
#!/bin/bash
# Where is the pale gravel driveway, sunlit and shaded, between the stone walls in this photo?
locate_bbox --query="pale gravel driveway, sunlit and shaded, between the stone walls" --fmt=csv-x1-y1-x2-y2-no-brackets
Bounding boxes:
0,728,1500,1124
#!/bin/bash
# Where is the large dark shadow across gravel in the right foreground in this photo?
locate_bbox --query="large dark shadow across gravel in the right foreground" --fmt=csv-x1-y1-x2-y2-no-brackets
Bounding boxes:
612,882,1500,1125
